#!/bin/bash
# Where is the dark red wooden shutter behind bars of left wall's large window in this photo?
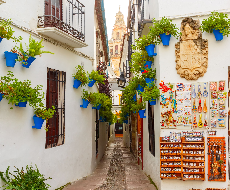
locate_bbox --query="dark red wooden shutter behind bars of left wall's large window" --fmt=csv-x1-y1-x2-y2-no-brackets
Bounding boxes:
46,71,59,146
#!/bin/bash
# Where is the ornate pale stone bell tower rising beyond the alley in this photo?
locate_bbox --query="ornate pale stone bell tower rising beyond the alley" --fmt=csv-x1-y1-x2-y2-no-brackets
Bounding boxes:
109,7,126,77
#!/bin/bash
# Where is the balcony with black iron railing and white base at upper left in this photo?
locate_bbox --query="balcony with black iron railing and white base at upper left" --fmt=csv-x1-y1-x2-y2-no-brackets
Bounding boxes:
37,0,87,48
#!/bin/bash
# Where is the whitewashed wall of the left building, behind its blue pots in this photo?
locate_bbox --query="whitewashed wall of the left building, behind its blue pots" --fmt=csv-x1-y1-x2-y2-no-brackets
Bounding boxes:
0,0,108,190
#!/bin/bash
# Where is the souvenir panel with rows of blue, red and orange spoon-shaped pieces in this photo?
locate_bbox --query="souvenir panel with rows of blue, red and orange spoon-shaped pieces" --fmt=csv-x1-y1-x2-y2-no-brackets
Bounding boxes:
191,82,210,130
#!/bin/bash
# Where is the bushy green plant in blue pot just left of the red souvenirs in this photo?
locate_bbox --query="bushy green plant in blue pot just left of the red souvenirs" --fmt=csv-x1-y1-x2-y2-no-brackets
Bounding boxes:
141,85,160,105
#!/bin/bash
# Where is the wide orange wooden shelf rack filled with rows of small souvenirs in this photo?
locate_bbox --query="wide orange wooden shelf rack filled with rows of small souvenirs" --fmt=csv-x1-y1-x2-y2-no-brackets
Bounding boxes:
160,131,205,181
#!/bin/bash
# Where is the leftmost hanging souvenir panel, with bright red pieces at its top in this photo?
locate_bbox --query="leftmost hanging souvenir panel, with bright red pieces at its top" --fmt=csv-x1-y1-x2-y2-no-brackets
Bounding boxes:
159,82,177,129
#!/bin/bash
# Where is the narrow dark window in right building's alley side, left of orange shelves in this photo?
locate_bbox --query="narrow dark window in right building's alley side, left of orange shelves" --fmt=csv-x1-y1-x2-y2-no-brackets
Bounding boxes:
148,102,155,156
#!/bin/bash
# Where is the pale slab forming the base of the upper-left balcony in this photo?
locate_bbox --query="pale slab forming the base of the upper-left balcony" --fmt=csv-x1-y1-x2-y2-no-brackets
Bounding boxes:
36,27,88,48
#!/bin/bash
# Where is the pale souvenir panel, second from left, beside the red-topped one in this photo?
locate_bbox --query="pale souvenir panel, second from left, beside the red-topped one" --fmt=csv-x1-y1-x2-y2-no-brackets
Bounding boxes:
176,83,192,129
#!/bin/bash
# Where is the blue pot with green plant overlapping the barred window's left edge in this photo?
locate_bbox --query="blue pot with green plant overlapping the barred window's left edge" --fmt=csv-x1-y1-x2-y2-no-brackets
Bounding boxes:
32,106,56,129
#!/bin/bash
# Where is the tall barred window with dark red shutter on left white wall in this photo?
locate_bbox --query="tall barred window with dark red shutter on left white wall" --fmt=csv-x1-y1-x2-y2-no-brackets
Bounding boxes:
45,68,66,148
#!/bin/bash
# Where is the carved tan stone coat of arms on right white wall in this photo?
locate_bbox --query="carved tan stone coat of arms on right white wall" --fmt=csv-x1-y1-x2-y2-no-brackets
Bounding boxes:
175,17,208,80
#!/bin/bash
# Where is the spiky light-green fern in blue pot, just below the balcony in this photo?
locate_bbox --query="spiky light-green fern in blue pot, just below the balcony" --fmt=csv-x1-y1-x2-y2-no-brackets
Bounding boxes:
15,35,54,68
